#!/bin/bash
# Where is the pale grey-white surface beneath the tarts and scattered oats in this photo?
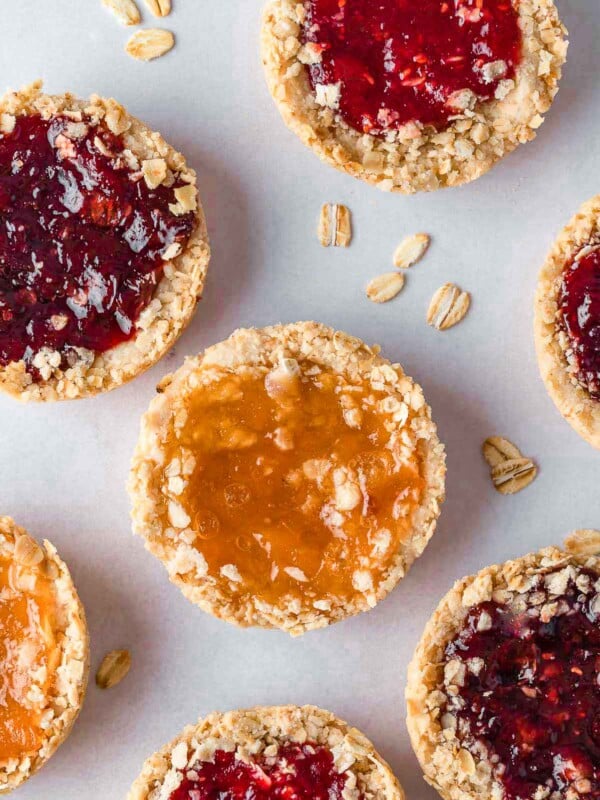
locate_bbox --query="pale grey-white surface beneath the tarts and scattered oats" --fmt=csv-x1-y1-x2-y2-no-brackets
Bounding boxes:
0,0,600,800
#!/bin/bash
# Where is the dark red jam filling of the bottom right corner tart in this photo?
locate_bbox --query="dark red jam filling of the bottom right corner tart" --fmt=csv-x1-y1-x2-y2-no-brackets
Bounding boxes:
446,570,600,800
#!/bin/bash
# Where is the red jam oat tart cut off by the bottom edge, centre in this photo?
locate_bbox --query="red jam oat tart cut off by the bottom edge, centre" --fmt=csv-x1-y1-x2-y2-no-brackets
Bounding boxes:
127,706,404,800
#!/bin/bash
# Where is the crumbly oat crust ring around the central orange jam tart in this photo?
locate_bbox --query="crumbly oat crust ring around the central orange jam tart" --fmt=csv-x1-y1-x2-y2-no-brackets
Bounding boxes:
129,322,445,634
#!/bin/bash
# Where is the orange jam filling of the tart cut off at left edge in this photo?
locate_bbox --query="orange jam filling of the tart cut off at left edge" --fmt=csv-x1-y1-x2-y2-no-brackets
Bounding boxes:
0,559,58,761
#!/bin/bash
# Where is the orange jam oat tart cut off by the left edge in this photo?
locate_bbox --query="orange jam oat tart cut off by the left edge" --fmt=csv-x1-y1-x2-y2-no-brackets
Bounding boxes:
0,517,89,793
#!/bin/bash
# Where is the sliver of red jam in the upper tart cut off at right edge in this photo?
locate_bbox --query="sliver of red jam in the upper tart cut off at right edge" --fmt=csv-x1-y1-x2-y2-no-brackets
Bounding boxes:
559,247,600,400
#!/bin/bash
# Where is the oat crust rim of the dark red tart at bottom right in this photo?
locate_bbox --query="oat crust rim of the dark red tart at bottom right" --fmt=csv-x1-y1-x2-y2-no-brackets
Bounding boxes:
406,547,600,800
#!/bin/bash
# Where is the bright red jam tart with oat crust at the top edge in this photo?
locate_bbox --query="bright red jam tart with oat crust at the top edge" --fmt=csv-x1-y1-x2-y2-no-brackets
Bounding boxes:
262,0,567,194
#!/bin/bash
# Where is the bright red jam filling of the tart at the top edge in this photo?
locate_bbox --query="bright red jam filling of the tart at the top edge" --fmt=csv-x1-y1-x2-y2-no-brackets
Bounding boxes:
303,0,522,135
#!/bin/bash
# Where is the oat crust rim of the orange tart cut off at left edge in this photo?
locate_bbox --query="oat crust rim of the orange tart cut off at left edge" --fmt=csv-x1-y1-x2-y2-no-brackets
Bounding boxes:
0,517,89,793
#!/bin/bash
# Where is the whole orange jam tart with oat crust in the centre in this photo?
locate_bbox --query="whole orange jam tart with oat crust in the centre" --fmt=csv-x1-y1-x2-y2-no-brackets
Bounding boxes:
130,322,445,634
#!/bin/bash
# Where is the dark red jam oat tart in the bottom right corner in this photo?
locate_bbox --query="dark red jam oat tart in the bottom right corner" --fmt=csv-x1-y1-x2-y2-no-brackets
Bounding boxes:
406,548,600,800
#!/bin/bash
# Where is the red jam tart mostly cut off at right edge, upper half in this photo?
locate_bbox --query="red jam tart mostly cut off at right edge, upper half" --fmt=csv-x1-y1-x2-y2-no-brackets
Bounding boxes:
535,195,600,449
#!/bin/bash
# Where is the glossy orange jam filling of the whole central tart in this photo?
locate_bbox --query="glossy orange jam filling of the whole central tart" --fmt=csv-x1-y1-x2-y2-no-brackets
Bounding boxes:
164,359,423,610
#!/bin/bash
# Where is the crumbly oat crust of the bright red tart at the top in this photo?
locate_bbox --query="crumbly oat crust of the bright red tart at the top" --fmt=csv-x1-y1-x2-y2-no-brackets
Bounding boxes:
261,0,567,194
